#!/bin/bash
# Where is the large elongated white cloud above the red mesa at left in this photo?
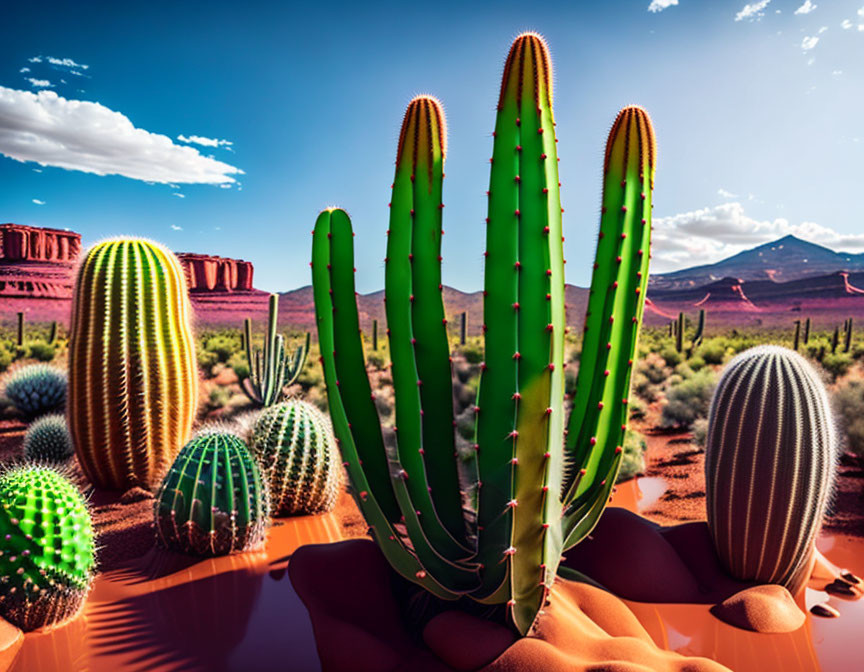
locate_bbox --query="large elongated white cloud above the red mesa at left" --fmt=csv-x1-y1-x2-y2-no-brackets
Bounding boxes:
0,86,243,184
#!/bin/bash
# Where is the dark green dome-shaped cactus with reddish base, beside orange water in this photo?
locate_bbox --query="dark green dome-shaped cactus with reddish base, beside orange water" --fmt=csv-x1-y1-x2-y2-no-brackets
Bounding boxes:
154,429,269,556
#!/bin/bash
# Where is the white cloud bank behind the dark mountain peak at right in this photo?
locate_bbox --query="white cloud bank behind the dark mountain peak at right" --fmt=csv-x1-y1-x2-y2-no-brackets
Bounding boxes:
651,202,864,273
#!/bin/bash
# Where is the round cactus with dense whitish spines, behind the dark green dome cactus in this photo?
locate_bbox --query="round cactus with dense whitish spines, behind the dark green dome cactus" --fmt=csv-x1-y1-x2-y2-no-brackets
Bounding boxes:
252,399,341,515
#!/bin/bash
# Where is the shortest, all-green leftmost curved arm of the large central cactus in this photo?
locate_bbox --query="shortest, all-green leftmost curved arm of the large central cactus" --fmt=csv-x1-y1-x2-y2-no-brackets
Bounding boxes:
312,210,476,599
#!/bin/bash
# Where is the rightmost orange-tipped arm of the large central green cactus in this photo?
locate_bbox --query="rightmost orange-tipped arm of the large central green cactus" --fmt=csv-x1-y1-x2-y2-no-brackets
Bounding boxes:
564,107,656,545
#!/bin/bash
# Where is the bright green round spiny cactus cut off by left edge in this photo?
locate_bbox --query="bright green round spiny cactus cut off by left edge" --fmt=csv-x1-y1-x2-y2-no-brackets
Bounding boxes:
0,466,95,630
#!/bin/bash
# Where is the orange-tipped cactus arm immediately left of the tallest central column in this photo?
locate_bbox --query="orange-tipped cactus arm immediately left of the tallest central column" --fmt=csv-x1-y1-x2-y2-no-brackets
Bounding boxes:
385,96,470,560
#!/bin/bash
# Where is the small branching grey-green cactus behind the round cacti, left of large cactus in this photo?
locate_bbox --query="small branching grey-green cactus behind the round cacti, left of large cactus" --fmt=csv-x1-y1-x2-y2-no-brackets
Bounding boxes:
241,294,310,407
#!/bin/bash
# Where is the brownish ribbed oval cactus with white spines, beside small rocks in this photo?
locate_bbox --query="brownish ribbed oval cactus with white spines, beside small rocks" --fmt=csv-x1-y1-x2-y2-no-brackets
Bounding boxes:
705,346,837,594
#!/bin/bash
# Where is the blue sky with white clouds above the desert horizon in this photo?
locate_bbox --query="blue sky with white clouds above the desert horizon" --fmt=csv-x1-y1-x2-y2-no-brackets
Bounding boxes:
0,0,864,291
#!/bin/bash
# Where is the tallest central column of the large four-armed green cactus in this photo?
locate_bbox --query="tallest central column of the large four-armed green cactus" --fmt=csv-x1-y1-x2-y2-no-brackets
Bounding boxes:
478,34,564,634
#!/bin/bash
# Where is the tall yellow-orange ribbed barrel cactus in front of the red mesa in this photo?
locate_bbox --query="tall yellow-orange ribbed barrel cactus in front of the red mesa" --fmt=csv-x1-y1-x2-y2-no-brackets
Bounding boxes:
67,238,198,489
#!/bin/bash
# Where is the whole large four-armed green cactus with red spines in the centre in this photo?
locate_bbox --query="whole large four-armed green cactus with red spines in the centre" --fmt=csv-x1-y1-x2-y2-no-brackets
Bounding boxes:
312,33,655,634
